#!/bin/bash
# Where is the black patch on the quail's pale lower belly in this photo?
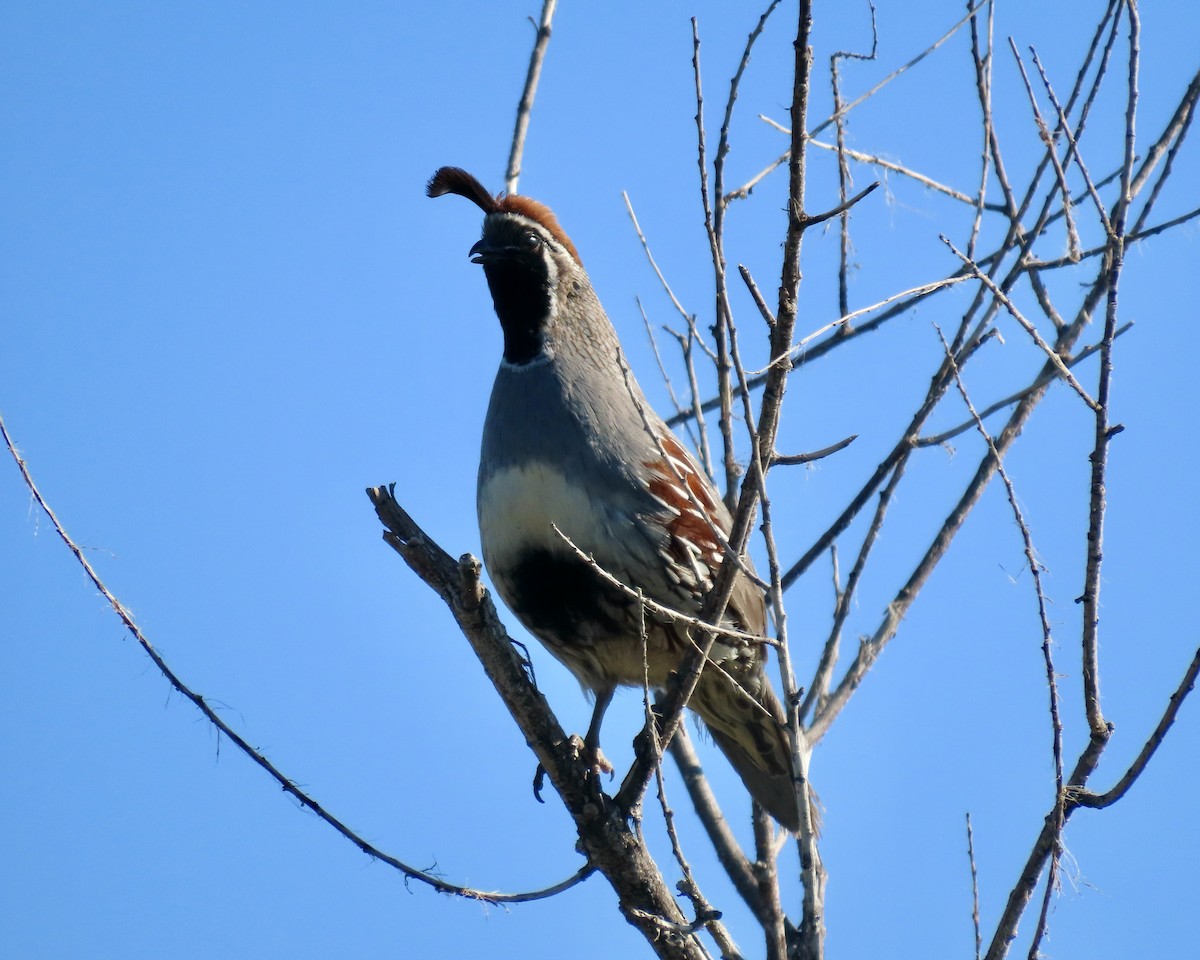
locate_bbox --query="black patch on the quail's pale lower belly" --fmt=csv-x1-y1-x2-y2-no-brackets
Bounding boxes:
510,550,632,646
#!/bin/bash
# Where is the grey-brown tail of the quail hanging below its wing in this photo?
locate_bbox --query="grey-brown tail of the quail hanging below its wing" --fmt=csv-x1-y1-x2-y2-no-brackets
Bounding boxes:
689,664,811,833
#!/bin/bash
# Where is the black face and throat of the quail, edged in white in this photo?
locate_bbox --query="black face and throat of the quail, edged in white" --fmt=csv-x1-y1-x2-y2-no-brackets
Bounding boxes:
470,218,551,364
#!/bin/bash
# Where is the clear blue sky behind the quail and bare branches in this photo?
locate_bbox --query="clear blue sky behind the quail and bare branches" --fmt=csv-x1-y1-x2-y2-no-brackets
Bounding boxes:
0,1,1200,958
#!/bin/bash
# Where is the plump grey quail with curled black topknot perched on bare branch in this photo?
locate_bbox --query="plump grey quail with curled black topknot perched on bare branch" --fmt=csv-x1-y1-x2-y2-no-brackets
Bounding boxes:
426,167,800,833
